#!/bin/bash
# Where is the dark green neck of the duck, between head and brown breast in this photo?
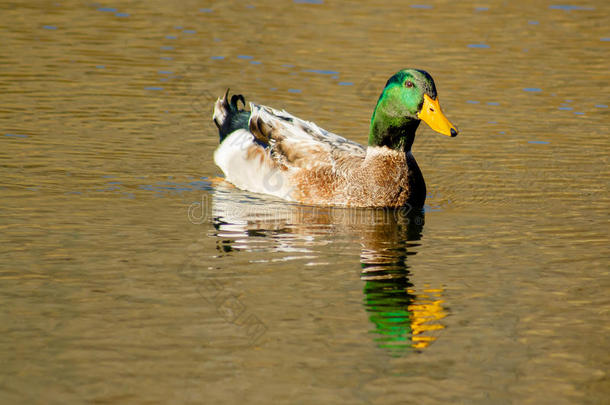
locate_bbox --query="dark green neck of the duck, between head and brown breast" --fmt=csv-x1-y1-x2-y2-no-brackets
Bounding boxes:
369,108,420,153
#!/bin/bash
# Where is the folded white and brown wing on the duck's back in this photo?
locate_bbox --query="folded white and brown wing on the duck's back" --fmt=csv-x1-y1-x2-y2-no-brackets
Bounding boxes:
248,103,366,169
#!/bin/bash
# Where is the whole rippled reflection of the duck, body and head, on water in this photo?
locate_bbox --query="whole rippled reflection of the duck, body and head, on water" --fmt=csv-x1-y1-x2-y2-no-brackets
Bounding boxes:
204,181,447,355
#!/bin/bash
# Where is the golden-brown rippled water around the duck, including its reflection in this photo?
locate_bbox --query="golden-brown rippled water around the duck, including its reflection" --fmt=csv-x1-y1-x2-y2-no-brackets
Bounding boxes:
0,0,610,404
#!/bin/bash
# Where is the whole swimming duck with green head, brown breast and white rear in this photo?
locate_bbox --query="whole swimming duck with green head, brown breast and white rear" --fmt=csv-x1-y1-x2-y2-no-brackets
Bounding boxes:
213,69,458,207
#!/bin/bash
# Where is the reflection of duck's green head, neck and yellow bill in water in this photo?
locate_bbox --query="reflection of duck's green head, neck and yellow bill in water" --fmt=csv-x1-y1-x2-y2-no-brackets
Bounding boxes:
360,211,446,356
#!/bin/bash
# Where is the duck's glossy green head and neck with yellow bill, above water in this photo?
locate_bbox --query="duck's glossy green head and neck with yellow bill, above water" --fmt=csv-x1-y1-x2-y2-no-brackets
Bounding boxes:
369,69,458,151
